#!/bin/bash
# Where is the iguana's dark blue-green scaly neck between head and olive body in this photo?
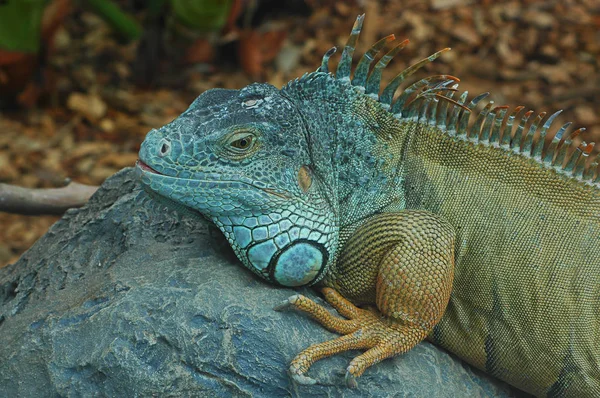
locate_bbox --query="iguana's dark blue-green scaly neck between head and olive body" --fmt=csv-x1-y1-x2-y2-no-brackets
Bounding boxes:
282,72,409,228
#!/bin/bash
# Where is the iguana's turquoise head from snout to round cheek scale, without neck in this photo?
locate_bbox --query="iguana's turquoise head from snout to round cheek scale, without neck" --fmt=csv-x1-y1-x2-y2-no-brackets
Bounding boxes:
138,84,338,286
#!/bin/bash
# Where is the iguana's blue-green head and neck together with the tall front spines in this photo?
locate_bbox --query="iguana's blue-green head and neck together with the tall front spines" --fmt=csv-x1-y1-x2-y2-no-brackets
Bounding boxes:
138,16,454,286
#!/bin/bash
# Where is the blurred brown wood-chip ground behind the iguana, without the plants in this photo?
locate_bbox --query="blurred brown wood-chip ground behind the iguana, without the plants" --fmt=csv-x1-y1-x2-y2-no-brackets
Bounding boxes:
0,0,600,267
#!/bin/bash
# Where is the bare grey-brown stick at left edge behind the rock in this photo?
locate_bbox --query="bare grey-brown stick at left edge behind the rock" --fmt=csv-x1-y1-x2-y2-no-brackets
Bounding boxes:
0,182,98,215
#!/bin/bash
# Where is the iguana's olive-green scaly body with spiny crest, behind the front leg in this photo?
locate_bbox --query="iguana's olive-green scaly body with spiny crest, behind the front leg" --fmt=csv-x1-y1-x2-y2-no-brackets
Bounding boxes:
304,16,600,396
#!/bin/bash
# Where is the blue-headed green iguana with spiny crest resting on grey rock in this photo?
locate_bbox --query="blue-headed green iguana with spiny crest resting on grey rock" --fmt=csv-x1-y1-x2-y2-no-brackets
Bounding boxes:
138,16,600,397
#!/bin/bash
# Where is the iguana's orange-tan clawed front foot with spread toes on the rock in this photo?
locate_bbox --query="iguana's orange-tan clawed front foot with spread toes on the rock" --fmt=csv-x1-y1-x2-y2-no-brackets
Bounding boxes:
276,288,428,388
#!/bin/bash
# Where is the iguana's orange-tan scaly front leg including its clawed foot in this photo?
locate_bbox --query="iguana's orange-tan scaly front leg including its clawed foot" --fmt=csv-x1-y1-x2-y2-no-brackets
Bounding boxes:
277,211,455,387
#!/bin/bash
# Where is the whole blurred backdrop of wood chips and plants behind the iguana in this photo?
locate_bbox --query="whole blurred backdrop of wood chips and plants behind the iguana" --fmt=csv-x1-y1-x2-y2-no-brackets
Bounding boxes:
0,0,600,266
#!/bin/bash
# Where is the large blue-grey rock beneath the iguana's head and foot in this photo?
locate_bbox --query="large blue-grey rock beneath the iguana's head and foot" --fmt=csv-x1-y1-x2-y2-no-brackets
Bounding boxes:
0,169,519,397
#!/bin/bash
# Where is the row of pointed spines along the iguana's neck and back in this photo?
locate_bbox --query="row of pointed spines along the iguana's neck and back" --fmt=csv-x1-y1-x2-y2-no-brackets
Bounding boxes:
318,14,600,186
